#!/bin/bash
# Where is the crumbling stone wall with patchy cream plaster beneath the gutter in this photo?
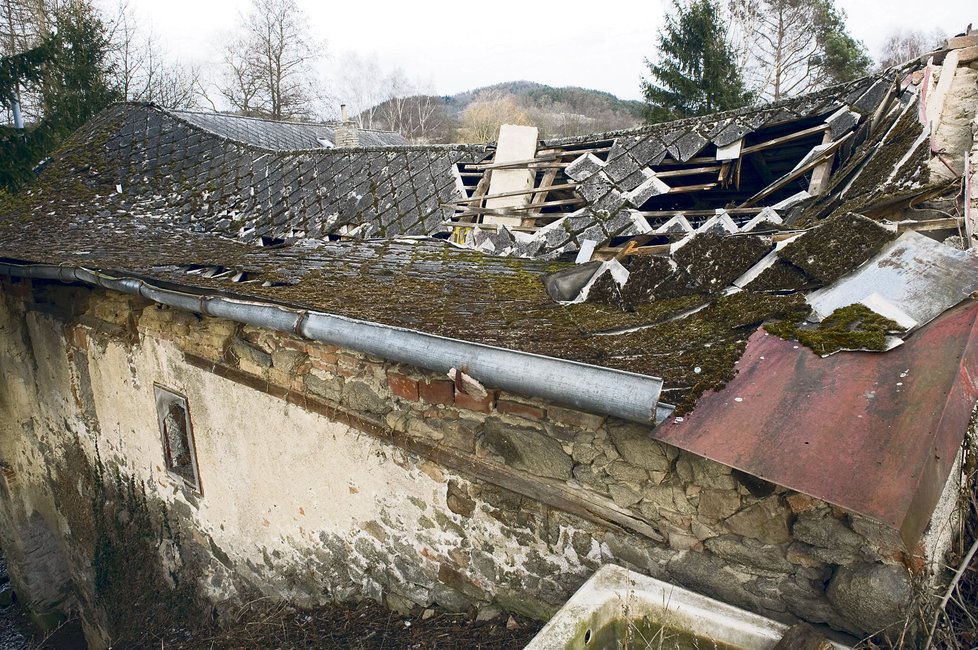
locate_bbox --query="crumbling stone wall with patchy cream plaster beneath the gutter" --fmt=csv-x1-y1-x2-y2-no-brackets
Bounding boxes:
0,274,948,634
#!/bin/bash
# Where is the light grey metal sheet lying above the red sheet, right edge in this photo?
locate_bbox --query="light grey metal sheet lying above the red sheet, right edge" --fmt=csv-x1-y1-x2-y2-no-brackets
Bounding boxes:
807,232,978,327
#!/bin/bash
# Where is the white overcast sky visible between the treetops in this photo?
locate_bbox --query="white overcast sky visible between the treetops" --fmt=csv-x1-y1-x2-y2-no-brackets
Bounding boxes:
130,0,978,99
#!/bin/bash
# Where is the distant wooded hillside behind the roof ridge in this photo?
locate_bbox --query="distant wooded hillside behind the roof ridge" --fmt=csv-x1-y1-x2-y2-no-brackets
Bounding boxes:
363,81,643,142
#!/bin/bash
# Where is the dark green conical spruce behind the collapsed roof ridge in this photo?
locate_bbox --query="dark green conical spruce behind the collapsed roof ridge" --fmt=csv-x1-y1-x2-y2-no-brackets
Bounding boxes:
642,0,751,123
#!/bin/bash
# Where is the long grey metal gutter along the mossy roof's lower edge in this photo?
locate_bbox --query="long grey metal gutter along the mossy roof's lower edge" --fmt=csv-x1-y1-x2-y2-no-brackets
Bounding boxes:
0,262,673,424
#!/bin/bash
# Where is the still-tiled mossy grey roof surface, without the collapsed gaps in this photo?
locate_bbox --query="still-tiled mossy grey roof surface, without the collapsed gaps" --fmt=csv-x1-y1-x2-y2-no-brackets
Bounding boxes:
0,60,960,407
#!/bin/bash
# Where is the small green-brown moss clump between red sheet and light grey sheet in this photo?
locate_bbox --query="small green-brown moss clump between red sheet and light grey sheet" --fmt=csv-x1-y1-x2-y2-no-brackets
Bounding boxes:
764,304,904,354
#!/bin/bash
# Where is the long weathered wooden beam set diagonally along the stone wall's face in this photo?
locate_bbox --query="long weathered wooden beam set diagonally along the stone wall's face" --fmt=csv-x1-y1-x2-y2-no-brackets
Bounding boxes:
184,353,664,542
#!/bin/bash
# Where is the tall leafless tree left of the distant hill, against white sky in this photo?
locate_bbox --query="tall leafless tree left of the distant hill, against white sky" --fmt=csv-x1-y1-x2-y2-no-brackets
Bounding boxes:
219,0,322,119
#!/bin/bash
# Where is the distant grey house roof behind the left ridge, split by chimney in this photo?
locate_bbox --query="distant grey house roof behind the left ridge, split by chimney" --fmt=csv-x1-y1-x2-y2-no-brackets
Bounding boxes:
170,111,408,151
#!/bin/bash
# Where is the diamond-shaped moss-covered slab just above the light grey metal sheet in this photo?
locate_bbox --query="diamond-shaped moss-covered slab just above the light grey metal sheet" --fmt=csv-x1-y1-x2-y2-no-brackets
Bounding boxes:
778,213,896,285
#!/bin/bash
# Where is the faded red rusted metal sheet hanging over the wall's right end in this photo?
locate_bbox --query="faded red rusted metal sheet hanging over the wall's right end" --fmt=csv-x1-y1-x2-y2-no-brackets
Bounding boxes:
655,301,978,547
